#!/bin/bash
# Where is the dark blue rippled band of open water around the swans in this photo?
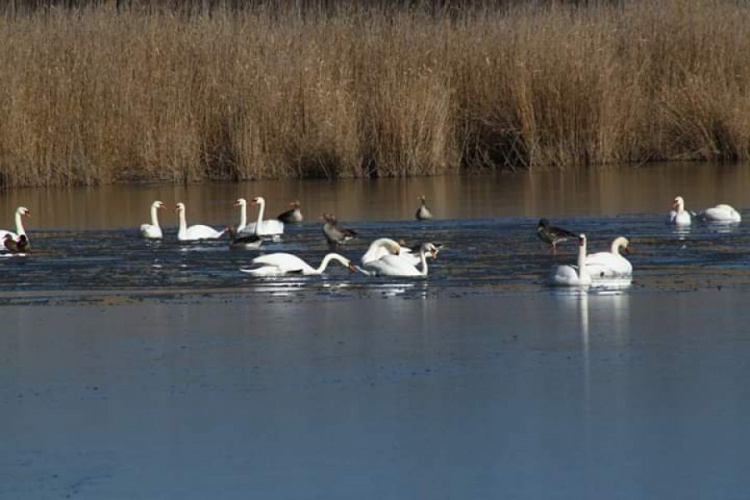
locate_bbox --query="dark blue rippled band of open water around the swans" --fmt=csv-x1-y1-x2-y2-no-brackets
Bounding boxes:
0,214,750,303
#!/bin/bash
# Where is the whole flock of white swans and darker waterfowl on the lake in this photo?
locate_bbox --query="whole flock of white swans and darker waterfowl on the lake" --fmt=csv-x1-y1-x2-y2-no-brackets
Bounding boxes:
0,196,741,287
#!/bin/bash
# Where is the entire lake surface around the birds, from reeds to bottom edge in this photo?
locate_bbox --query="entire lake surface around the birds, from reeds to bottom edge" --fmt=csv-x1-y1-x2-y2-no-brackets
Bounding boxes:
0,165,750,499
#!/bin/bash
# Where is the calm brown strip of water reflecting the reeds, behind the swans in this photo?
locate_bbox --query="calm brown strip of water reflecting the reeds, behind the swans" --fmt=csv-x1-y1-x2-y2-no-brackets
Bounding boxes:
0,163,750,231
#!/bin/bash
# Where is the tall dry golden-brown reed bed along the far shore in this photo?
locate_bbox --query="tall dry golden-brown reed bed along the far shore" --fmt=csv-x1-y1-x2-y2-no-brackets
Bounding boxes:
0,0,750,186
